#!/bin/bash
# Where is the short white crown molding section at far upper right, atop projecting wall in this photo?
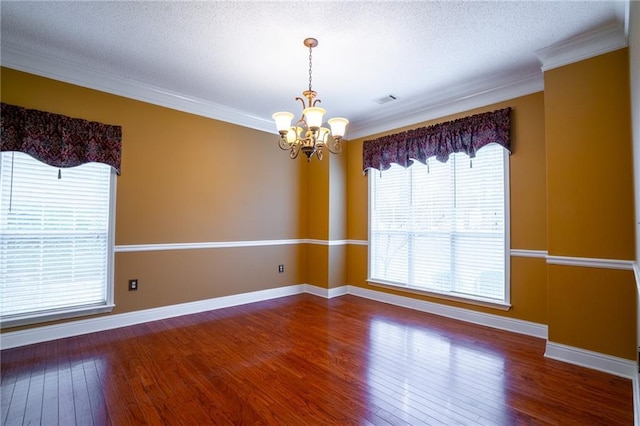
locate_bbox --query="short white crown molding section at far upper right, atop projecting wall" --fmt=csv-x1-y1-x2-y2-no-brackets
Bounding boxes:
536,24,627,71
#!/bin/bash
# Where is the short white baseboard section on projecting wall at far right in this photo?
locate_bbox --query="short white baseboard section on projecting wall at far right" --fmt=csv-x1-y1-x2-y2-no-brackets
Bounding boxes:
544,341,638,380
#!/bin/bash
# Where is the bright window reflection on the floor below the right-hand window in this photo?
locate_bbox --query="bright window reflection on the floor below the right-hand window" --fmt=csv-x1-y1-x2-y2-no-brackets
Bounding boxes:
367,318,506,424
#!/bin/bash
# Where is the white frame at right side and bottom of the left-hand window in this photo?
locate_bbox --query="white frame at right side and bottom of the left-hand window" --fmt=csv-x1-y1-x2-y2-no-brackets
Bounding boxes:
0,156,117,329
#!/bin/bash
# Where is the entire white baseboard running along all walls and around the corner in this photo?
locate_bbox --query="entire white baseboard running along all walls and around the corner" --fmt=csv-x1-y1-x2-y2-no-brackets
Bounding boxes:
0,284,640,388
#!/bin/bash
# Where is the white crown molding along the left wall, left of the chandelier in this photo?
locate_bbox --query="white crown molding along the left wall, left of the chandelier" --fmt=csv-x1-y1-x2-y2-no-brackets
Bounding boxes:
0,44,275,133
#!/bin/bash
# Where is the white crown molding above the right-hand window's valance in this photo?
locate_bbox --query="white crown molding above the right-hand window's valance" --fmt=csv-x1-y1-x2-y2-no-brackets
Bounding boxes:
347,71,544,139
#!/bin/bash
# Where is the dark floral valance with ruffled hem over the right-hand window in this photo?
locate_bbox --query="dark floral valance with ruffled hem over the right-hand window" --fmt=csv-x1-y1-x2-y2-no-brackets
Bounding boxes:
362,108,511,173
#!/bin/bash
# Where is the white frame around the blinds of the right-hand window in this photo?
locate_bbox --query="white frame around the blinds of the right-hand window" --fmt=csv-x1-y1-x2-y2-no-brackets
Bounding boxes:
367,144,511,311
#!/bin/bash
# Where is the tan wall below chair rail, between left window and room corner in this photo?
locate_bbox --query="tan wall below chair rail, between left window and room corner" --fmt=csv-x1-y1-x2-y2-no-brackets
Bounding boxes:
113,244,307,314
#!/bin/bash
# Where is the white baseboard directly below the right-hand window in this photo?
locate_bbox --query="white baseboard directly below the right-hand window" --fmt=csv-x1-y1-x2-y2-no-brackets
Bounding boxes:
348,286,547,339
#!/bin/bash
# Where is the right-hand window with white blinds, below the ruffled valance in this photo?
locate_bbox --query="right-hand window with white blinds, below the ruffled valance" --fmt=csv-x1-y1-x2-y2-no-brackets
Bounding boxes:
369,144,509,306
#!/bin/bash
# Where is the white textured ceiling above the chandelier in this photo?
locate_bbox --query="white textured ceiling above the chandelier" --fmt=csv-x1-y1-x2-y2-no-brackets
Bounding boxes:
0,1,628,137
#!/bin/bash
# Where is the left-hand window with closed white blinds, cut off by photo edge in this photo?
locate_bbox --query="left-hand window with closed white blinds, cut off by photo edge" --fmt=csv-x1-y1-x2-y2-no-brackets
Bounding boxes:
0,152,115,327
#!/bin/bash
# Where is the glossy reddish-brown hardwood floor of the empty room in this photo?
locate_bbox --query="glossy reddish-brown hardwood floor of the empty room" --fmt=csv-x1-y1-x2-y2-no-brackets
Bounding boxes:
1,295,633,425
